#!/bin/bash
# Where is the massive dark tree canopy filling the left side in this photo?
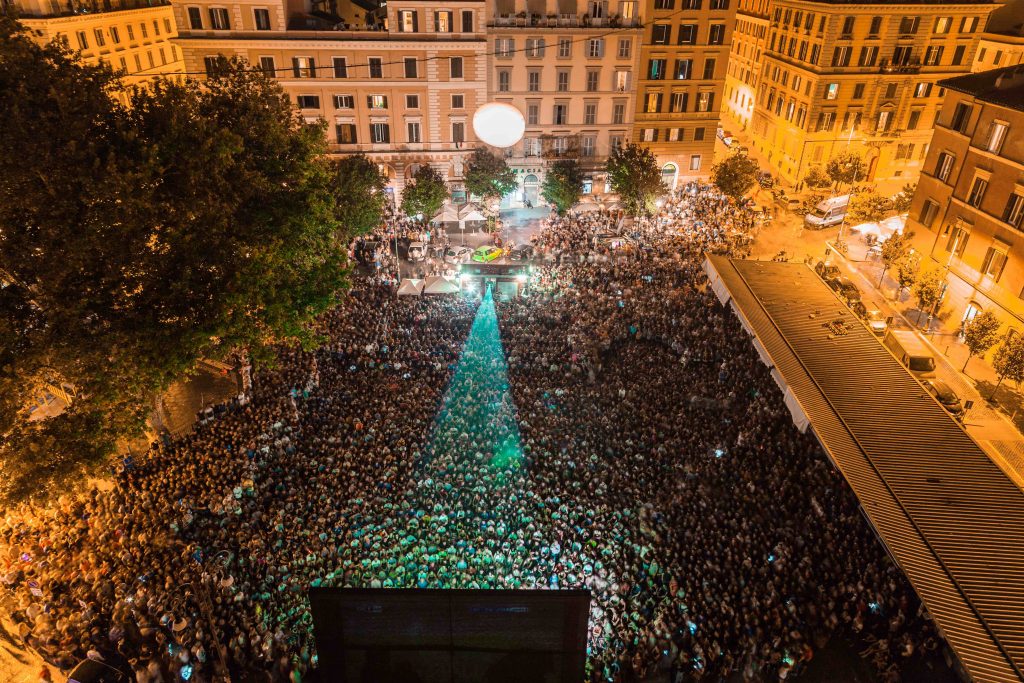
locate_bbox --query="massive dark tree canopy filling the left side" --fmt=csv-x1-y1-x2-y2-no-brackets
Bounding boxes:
0,24,346,494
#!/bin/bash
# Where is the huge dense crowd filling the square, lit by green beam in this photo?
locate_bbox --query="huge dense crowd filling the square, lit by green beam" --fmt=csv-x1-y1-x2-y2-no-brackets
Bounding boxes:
0,185,940,683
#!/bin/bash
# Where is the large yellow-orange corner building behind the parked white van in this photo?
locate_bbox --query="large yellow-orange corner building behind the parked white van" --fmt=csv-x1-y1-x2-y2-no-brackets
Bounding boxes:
751,0,994,191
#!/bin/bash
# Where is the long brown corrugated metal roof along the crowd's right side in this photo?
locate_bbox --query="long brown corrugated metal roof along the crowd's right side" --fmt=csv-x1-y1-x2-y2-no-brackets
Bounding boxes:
705,256,1024,682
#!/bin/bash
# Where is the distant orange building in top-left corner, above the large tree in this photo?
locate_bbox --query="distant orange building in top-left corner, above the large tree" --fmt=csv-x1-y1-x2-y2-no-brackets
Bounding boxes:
8,0,184,85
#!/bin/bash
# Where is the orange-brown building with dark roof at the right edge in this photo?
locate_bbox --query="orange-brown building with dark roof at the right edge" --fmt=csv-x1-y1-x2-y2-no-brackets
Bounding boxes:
909,65,1024,333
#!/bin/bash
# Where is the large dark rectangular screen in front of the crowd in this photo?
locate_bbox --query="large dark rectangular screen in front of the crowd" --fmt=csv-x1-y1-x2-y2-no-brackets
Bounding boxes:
309,588,590,683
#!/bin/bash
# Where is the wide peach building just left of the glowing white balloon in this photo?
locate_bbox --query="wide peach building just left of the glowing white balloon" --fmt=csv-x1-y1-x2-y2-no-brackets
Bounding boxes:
173,0,487,201
